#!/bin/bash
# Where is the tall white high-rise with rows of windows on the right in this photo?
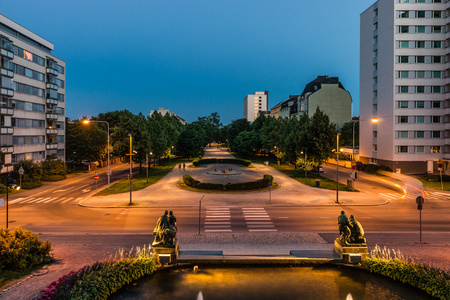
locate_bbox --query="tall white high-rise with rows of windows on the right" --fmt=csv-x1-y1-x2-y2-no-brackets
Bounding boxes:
360,0,450,173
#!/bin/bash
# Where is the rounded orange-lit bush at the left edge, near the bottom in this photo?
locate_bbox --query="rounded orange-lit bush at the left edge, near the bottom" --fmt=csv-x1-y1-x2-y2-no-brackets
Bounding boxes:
0,227,54,271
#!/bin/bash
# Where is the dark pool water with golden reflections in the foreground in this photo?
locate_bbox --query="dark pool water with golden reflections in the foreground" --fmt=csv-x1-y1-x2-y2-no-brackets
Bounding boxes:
111,266,432,300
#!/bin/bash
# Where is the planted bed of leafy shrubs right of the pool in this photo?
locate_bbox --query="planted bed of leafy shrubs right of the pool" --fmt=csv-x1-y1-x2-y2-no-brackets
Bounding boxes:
362,246,450,300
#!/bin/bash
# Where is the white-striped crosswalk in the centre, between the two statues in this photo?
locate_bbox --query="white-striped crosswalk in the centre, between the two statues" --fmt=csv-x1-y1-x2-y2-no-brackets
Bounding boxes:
204,206,277,233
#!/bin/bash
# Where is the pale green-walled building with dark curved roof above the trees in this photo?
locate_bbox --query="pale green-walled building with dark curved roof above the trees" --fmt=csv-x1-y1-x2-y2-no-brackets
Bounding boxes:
295,75,352,128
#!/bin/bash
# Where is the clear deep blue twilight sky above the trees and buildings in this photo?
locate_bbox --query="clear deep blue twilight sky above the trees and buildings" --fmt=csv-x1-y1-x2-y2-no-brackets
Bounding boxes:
0,0,375,124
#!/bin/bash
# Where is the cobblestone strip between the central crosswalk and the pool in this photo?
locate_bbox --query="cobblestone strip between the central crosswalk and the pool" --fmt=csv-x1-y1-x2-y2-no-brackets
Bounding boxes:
178,232,326,245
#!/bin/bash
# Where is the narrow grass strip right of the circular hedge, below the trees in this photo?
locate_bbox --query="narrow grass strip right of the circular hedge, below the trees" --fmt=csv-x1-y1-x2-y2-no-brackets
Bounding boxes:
273,165,359,192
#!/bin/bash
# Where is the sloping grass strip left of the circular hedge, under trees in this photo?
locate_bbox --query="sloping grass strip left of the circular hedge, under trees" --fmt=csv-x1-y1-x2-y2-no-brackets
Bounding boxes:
95,158,192,196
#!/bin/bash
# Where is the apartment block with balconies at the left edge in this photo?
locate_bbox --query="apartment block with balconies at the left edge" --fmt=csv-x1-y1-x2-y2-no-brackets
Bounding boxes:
0,14,65,173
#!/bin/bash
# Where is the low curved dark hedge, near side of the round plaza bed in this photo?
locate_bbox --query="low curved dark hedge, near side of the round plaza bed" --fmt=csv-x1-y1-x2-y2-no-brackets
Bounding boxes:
183,174,273,191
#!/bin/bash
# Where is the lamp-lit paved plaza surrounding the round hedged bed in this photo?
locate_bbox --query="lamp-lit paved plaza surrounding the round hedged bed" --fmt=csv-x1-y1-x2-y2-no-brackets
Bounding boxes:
79,149,389,207
